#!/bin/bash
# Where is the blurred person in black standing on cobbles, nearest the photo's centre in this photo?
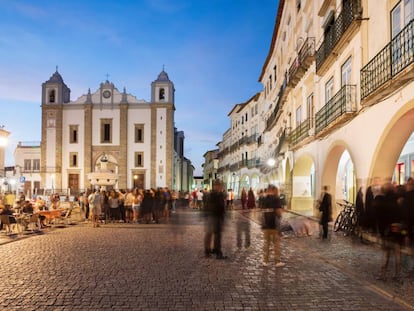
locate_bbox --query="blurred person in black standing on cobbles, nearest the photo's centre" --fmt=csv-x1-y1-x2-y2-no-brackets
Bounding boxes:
204,179,227,259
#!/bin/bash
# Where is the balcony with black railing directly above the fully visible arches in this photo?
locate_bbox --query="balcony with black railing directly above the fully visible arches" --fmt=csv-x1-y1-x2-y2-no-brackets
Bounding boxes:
315,85,356,136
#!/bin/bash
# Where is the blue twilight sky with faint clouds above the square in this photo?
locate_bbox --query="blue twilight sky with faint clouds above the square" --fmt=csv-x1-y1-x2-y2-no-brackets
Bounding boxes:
0,0,278,175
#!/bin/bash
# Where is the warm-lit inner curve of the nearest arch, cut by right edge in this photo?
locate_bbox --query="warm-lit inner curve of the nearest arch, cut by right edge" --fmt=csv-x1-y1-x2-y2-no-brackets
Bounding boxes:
367,100,414,183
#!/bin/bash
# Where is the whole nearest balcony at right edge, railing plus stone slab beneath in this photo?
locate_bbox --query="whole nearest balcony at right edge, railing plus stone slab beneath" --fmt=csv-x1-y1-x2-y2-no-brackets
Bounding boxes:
361,20,414,104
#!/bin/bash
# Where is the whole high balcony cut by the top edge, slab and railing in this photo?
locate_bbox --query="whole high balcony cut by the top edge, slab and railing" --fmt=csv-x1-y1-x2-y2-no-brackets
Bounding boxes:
316,0,362,75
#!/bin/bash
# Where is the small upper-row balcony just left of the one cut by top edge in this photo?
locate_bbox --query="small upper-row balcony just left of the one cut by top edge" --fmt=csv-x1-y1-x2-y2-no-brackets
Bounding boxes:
288,38,315,87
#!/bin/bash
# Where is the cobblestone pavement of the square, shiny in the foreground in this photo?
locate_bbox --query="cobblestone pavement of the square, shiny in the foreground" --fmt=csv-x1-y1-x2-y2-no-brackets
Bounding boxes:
0,210,414,310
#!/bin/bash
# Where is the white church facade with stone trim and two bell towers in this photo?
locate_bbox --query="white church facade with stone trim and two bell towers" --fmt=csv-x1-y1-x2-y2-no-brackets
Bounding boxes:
41,70,183,193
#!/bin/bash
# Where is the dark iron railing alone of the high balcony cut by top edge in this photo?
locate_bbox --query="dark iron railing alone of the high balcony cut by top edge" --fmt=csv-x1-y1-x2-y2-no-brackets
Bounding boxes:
316,0,361,71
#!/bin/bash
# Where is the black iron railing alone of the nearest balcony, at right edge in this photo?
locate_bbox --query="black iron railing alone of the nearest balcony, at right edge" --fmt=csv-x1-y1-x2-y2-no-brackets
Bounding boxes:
361,20,414,99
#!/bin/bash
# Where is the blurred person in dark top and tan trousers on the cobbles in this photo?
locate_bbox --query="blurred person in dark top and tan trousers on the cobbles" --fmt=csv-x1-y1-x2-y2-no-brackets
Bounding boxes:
262,185,286,267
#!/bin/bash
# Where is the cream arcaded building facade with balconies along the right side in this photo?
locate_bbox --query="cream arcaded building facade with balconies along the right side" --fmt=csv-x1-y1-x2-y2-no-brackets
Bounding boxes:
215,0,414,215
